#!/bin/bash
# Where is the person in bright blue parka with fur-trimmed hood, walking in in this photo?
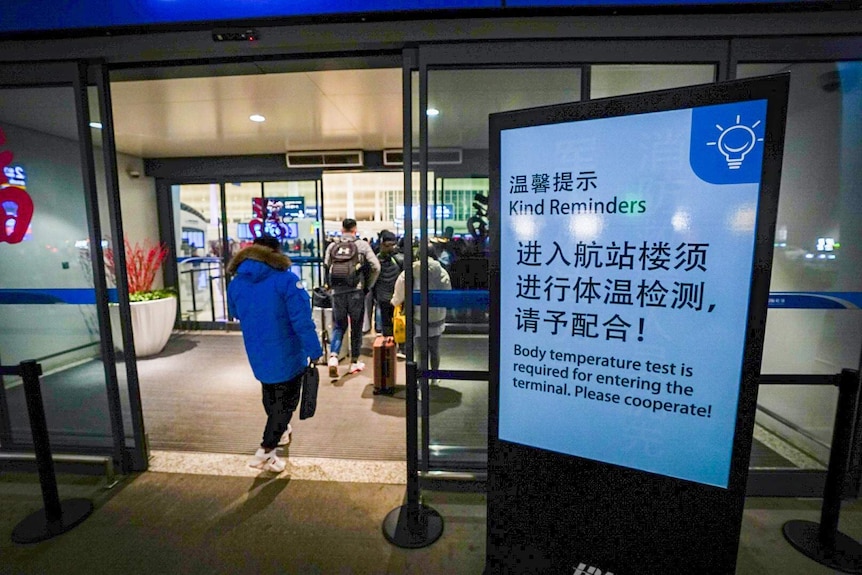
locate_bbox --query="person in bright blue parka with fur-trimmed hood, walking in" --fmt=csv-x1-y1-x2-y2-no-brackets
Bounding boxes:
227,236,323,473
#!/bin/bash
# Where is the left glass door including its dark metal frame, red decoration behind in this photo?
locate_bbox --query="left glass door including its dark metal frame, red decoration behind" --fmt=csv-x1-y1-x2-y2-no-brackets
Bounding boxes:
0,63,146,470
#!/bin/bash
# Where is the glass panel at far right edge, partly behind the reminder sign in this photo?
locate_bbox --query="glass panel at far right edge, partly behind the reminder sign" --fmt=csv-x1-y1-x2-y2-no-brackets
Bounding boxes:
737,62,862,462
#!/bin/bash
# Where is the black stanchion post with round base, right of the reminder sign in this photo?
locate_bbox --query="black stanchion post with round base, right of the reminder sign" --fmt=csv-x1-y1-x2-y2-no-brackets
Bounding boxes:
783,369,862,573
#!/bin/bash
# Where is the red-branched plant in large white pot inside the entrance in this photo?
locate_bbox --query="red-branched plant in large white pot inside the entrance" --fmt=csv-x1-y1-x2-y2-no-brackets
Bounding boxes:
105,240,177,357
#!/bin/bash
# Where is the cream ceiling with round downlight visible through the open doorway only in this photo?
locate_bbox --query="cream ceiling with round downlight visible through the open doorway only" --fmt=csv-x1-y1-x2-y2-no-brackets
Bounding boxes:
111,69,402,158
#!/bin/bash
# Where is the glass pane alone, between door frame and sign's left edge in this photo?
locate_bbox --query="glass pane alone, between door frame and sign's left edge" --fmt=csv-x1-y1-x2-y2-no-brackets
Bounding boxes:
426,68,581,469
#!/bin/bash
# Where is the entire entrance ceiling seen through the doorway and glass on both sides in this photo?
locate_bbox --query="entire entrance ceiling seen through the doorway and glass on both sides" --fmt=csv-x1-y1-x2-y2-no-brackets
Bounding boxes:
0,63,728,164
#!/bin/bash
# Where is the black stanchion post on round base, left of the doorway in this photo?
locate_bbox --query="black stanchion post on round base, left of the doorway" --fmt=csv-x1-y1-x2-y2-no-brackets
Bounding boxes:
12,360,93,543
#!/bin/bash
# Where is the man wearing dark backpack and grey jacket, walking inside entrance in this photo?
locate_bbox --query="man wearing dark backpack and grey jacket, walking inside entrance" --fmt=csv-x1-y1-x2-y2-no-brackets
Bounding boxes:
323,218,380,377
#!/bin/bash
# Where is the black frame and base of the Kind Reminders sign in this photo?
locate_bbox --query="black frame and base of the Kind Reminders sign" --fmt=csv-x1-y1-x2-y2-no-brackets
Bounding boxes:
486,74,789,575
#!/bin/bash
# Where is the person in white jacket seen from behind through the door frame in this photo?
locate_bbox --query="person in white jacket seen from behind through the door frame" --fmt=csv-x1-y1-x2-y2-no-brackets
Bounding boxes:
392,245,452,385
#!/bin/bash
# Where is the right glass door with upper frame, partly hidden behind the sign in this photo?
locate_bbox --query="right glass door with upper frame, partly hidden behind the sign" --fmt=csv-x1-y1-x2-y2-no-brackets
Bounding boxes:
413,42,725,473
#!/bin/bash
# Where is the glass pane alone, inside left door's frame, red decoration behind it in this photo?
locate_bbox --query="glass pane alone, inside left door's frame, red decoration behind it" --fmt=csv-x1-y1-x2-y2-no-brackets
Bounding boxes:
0,87,112,452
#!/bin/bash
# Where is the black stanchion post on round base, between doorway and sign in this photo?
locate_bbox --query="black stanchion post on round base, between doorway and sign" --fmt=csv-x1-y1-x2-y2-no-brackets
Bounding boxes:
383,361,443,549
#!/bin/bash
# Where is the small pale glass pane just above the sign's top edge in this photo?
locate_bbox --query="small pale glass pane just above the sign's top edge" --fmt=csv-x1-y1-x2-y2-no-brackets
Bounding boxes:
590,64,715,100
